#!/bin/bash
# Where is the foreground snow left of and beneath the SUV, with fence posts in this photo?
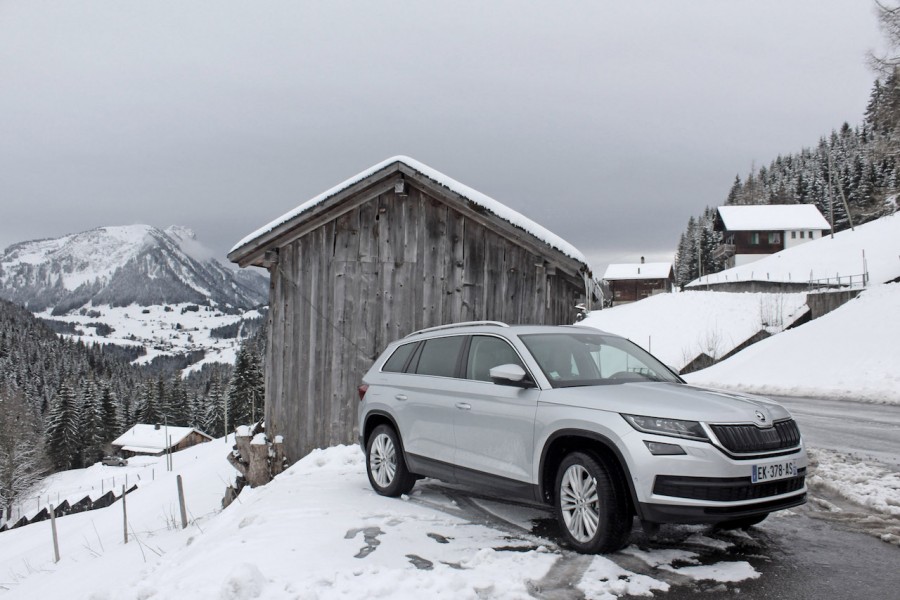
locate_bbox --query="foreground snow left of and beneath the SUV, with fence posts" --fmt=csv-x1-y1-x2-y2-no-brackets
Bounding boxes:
0,438,760,600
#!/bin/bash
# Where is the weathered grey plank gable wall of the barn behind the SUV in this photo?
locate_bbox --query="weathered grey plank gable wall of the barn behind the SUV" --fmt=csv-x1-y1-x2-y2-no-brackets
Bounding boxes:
266,186,584,460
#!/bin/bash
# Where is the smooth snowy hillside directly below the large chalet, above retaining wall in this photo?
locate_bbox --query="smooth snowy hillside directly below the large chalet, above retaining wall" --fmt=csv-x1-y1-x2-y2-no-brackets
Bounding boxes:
687,213,900,288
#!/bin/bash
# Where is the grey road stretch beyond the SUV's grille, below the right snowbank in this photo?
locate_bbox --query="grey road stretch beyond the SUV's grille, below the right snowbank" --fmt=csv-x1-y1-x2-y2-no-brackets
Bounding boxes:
772,397,900,470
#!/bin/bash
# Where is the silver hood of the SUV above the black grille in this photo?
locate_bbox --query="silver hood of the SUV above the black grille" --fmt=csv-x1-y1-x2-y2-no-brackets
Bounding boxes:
540,382,791,425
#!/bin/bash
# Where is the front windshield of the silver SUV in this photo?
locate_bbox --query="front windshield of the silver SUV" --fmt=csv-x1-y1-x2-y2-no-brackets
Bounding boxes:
519,332,681,388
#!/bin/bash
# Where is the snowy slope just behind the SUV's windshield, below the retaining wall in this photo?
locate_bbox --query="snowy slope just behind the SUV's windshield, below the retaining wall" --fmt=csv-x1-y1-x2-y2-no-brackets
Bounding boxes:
578,292,807,370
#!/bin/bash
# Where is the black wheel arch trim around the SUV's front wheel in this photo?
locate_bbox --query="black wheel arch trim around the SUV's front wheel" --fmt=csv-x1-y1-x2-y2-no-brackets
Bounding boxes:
538,429,641,517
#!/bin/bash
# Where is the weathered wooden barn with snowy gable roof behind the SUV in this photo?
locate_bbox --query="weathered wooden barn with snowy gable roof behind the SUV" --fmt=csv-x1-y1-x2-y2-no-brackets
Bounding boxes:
228,157,594,462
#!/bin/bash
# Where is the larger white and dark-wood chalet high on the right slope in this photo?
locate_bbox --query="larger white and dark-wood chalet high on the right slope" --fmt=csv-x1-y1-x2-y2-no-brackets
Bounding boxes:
713,204,831,268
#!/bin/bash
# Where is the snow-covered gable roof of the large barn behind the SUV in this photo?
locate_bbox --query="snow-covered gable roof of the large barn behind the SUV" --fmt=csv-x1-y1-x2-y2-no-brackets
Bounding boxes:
228,156,588,267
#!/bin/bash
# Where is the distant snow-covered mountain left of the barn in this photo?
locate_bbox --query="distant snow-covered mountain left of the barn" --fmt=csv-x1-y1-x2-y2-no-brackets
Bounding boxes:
0,225,268,315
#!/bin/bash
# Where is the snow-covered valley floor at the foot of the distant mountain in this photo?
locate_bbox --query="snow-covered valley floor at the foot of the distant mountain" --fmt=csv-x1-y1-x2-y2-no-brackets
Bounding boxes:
36,303,259,374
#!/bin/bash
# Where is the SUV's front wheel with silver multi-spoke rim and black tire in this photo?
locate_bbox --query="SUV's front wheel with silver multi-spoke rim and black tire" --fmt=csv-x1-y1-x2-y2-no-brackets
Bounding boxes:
554,452,633,554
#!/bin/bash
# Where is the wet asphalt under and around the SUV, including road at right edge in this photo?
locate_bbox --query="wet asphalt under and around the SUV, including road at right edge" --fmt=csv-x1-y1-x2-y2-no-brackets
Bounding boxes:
414,398,900,600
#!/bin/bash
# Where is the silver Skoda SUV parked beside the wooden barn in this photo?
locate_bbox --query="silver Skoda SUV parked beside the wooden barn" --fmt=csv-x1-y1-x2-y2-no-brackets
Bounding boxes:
359,321,807,553
